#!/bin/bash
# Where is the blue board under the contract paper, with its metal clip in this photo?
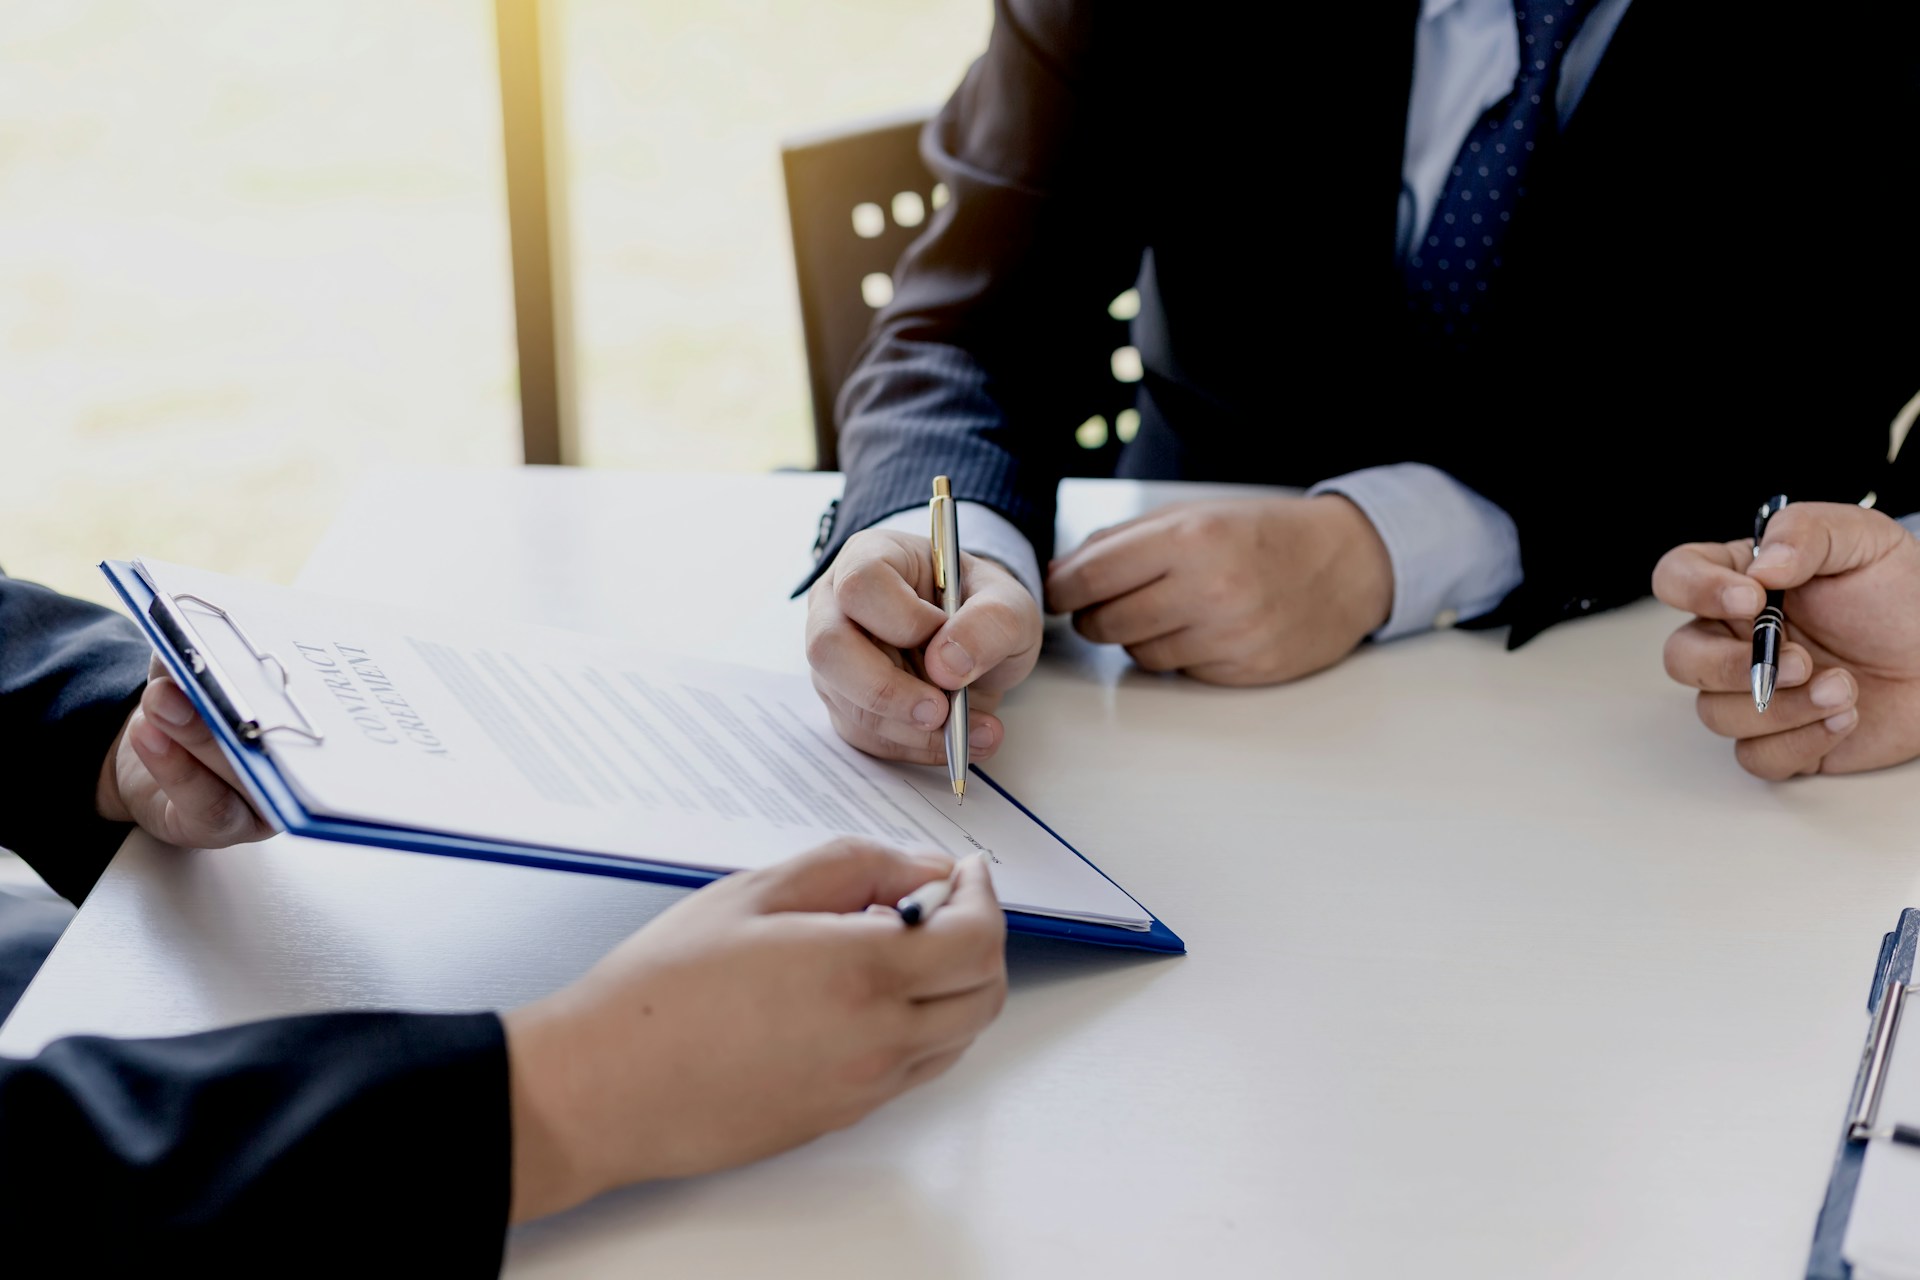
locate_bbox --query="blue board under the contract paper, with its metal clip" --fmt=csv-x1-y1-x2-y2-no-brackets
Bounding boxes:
100,560,1187,954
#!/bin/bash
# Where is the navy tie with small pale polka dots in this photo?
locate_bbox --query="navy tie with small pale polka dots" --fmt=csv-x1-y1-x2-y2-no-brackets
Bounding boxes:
1407,0,1594,349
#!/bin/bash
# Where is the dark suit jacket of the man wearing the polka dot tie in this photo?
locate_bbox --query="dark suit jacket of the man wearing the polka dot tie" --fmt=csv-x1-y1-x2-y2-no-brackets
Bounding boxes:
822,0,1920,643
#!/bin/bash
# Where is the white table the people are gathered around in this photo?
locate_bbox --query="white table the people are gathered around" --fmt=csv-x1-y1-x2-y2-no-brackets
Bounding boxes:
0,470,1920,1280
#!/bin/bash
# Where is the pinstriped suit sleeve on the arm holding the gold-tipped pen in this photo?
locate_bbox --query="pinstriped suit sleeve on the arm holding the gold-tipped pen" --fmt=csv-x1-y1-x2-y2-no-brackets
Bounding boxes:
820,0,1144,583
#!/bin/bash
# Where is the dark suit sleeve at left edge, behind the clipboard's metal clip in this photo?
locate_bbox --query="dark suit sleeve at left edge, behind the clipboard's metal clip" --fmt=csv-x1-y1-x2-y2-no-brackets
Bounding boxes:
0,574,150,902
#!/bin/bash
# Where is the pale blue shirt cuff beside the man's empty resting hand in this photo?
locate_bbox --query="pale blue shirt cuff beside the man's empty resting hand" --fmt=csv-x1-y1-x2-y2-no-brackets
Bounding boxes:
1308,462,1521,641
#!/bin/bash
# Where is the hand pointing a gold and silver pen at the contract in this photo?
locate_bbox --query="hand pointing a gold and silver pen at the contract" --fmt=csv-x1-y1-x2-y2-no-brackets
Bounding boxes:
806,530,1041,764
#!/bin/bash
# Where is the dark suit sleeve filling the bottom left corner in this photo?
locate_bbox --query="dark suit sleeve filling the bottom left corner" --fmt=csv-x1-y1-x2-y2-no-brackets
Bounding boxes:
0,1013,511,1276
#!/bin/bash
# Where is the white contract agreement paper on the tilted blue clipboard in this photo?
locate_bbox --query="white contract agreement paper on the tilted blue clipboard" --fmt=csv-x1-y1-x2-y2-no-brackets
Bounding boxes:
142,560,1150,929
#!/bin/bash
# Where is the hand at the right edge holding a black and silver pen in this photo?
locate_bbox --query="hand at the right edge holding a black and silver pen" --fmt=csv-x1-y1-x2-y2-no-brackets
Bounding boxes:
1653,503,1920,779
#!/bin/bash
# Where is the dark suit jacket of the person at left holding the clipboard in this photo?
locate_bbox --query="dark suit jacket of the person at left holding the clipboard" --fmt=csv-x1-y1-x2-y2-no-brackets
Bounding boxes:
0,576,511,1274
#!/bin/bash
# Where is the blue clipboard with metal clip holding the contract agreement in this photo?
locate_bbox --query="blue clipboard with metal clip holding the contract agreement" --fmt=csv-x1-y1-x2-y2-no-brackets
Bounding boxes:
100,560,1187,954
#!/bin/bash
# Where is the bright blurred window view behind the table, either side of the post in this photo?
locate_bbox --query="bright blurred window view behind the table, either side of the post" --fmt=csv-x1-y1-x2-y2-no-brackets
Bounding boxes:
0,0,991,599
